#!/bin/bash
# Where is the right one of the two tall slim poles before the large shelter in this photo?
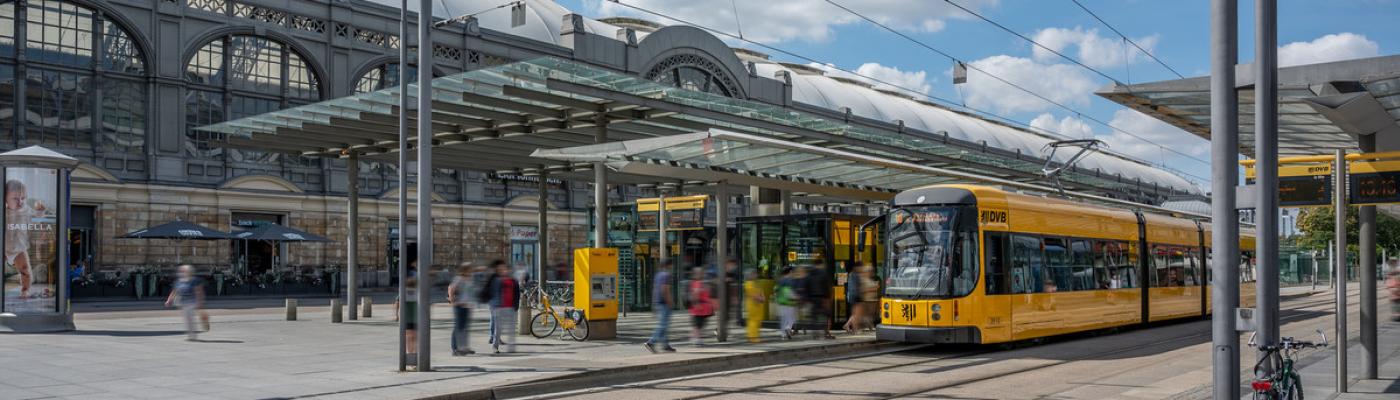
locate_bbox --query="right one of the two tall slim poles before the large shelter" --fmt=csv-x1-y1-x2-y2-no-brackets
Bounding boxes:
417,0,433,372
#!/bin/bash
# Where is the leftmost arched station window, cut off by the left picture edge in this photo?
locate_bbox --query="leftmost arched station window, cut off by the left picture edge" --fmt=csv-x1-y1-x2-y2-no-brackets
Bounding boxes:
0,0,148,172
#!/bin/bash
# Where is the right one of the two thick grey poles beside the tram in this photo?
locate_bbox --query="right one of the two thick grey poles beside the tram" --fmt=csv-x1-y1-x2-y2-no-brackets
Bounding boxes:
1254,0,1278,377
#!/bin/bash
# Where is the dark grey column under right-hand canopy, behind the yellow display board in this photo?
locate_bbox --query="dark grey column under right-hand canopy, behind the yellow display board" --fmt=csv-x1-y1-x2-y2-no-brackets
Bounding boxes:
1357,134,1378,379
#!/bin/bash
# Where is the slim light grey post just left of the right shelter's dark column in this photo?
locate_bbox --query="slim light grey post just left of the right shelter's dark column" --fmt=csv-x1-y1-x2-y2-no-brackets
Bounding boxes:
1331,148,1347,393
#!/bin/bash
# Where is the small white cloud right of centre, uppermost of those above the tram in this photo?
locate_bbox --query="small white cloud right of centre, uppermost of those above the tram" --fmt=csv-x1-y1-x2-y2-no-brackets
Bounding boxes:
1032,27,1159,69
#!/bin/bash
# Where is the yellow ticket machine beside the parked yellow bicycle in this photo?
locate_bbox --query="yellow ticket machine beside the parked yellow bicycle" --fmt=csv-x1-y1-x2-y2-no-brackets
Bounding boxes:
574,248,619,338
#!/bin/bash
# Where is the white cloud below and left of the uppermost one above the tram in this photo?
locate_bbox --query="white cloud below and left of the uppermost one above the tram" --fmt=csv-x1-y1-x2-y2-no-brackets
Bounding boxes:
962,55,1099,113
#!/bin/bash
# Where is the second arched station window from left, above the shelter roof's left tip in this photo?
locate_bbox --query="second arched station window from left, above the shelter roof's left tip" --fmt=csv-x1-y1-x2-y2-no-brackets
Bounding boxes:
185,35,321,160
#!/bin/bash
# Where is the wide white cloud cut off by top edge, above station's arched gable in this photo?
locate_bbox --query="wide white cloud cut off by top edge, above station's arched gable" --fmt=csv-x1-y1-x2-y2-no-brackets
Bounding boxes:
584,0,998,43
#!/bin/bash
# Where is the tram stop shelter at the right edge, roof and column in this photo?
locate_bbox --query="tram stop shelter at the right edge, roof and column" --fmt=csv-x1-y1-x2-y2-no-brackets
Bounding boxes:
1098,56,1400,387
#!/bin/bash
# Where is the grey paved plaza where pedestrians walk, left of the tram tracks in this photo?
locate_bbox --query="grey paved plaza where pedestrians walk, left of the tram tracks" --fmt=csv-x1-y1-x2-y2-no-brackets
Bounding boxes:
0,301,874,400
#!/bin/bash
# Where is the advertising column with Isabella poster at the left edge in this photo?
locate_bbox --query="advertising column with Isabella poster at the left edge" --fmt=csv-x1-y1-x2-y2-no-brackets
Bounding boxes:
0,145,78,333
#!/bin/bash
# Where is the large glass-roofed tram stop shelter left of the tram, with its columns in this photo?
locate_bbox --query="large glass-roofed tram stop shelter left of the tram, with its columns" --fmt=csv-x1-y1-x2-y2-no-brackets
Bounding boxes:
196,53,1201,349
